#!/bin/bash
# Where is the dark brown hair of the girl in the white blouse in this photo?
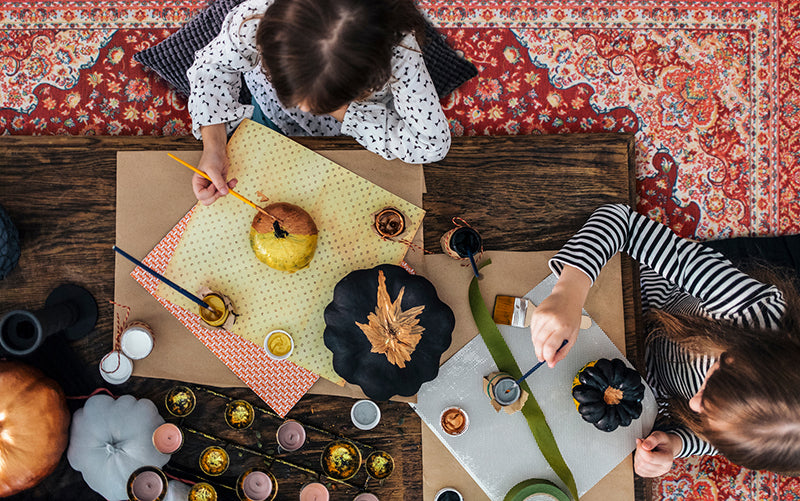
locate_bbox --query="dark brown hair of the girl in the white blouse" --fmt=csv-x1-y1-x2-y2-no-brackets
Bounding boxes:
256,0,425,114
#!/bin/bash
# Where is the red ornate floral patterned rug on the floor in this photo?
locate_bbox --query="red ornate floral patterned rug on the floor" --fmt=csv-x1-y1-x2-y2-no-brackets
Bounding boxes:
0,0,800,501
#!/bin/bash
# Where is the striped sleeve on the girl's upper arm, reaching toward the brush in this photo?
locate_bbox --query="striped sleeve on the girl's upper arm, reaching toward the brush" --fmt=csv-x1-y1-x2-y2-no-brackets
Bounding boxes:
550,204,785,328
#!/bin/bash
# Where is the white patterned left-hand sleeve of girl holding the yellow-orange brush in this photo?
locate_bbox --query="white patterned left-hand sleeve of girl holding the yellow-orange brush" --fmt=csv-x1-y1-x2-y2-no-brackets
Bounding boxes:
186,1,262,139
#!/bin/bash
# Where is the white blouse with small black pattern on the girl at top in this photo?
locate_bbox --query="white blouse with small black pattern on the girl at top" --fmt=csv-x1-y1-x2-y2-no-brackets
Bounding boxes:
187,0,450,163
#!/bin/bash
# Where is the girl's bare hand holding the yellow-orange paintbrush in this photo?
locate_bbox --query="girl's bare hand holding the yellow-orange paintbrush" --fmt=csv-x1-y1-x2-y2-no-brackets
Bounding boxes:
192,124,237,205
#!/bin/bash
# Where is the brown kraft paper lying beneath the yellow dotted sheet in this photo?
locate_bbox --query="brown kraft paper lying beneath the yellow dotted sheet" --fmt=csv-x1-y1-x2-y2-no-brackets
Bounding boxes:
114,150,424,390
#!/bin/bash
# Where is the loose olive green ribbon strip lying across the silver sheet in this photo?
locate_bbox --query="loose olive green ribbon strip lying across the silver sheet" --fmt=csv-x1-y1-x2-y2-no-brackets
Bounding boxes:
469,259,578,500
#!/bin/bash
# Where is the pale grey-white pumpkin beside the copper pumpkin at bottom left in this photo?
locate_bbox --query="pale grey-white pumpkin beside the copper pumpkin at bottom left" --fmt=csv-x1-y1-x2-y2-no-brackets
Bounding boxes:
67,395,171,499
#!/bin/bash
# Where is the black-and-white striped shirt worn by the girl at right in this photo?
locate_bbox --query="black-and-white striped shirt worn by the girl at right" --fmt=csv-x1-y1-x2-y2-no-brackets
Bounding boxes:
550,204,785,457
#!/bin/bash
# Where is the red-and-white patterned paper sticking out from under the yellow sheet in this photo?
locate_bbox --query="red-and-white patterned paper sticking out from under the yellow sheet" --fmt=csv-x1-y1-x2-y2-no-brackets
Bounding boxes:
131,208,319,417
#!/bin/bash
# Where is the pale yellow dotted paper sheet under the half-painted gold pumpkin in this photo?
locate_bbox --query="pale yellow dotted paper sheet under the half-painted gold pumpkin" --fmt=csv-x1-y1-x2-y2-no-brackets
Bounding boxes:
158,121,424,383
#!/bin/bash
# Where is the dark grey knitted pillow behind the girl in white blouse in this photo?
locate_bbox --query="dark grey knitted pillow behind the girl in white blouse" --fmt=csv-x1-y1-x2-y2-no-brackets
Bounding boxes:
133,0,478,103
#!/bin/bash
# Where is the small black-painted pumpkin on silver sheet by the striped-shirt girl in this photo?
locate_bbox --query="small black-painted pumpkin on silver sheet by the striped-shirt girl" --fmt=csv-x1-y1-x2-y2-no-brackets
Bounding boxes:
572,358,644,431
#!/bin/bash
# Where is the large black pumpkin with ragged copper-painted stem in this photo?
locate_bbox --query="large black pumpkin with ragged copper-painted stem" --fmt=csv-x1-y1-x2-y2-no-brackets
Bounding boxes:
323,264,455,400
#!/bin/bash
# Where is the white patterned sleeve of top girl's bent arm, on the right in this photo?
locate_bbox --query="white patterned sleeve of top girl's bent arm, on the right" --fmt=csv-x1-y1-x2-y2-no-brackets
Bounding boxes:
341,35,450,163
